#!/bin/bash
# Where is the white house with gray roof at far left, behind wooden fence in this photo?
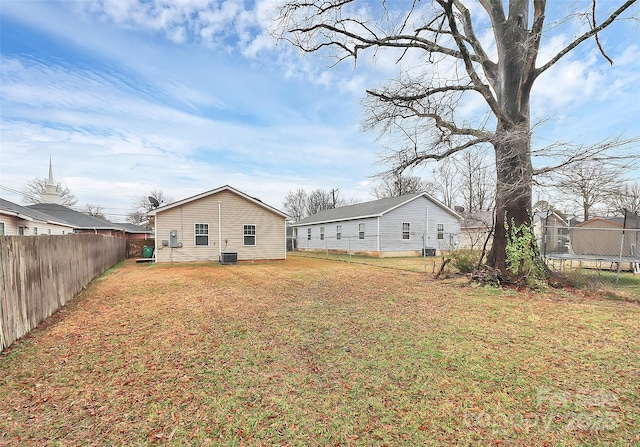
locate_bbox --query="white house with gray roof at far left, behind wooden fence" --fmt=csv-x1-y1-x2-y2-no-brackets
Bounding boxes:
0,199,74,236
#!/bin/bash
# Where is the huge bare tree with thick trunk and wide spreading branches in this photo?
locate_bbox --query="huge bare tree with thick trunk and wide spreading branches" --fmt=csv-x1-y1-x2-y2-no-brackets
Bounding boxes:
279,0,637,276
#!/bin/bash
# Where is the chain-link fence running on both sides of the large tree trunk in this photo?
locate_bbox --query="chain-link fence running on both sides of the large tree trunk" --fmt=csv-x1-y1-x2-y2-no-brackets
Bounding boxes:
289,218,640,299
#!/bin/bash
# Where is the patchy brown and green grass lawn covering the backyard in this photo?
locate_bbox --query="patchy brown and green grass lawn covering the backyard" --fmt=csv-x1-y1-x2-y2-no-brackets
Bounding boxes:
0,257,640,446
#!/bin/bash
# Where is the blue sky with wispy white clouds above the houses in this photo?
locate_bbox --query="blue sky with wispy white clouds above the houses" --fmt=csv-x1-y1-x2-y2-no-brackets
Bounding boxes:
0,0,640,220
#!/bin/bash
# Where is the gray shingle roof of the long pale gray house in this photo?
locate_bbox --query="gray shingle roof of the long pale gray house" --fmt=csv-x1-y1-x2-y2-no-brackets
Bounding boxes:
292,193,460,227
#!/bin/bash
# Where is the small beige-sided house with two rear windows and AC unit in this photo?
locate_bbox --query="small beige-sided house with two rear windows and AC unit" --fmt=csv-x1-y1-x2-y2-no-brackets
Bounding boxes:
148,186,287,262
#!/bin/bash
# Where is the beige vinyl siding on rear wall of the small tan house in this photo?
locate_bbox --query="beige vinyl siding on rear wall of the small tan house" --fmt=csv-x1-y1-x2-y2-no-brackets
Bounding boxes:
155,190,286,262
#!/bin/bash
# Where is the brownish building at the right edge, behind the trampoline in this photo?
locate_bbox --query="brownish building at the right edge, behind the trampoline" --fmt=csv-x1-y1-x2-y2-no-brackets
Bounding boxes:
569,217,640,257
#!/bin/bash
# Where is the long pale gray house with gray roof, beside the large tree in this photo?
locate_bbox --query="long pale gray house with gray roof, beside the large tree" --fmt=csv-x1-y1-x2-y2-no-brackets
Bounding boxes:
292,193,462,257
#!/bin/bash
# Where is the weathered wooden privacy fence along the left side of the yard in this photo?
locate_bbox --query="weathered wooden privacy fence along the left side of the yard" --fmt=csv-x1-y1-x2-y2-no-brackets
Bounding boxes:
0,234,126,350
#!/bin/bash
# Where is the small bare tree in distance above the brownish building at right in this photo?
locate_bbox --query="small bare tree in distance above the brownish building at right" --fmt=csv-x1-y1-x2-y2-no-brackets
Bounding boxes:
556,162,622,220
